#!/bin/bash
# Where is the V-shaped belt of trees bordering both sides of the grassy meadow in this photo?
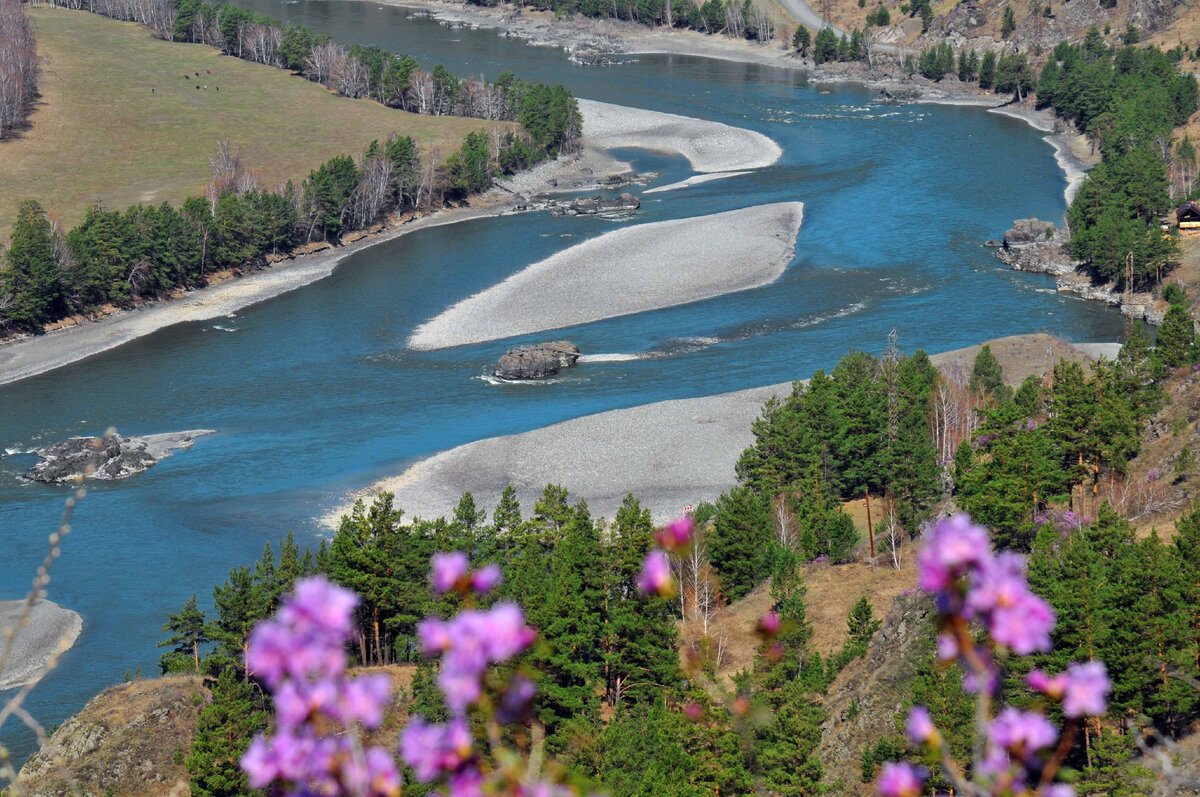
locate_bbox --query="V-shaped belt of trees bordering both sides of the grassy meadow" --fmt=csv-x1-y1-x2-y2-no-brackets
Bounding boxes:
0,6,581,332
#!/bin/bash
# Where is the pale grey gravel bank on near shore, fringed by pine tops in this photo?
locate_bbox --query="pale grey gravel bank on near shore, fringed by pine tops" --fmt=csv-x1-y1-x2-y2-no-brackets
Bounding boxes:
320,334,1121,528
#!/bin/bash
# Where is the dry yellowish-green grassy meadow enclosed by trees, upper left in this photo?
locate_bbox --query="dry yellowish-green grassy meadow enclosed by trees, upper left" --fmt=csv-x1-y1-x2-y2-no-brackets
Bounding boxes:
0,7,504,240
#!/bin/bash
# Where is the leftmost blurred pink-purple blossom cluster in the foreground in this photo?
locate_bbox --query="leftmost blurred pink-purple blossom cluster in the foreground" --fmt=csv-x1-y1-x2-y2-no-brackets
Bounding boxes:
241,577,400,797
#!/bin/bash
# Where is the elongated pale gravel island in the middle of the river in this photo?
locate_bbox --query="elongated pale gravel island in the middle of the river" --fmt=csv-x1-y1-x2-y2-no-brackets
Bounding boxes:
408,202,804,349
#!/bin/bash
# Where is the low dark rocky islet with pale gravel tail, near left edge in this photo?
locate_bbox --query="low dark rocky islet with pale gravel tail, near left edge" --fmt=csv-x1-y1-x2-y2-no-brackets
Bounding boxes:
25,429,212,484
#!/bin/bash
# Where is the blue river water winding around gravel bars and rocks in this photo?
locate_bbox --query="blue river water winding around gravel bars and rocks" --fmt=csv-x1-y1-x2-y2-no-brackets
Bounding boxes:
0,0,1123,757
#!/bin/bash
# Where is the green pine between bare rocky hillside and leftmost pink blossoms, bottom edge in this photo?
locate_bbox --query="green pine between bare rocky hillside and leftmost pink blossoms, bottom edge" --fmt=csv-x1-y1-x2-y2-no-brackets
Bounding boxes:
185,669,268,797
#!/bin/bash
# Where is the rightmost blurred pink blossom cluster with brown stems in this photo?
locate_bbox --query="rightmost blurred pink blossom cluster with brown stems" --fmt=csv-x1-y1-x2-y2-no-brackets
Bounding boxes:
876,515,1111,797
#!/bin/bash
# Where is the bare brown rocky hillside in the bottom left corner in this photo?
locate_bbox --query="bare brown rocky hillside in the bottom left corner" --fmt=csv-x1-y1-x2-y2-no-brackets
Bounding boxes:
19,676,209,797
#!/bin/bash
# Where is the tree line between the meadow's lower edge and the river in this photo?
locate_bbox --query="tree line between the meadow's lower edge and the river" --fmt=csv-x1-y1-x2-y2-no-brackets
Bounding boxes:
0,103,575,332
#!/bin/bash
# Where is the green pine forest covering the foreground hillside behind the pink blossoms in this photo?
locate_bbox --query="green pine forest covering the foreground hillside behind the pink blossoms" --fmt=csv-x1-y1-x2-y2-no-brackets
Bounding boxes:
136,326,1200,796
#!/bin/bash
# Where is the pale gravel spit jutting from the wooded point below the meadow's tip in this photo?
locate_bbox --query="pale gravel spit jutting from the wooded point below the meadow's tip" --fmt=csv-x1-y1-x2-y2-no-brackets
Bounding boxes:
578,100,784,172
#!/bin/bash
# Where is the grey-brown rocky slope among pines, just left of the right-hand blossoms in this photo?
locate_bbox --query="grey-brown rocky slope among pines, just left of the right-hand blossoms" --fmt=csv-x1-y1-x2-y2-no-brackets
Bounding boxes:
817,592,934,797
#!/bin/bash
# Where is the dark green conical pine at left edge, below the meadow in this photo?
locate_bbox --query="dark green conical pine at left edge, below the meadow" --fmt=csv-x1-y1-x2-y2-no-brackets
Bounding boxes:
0,199,64,332
